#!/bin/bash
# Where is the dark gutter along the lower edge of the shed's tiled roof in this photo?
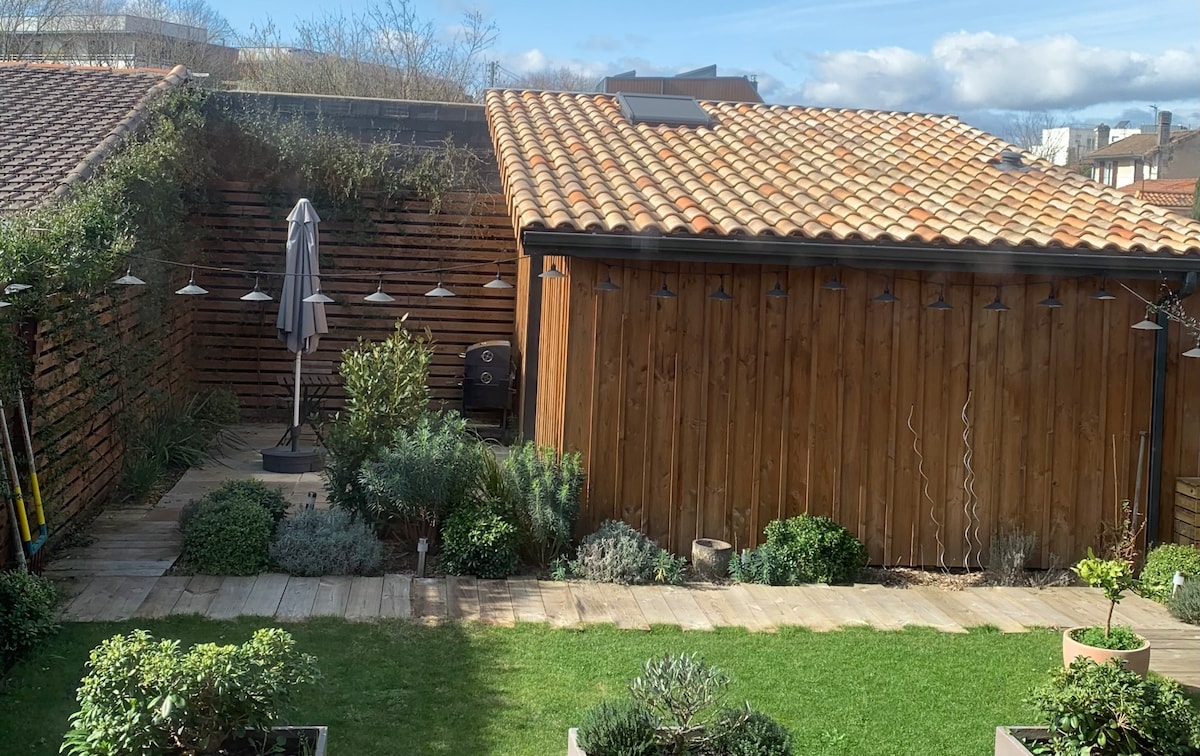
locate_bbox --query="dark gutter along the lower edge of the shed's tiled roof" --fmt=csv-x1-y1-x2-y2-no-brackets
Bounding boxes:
521,229,1200,278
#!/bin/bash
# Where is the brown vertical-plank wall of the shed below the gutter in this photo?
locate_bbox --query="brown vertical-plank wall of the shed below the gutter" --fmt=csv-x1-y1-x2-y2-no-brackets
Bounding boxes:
552,259,1200,566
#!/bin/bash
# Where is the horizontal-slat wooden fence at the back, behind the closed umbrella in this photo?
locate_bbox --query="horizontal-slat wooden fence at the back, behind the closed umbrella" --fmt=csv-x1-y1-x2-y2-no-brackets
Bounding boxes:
189,182,516,418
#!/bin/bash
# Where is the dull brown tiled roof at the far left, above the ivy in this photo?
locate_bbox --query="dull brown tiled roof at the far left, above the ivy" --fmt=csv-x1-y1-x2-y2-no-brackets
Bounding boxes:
0,64,188,211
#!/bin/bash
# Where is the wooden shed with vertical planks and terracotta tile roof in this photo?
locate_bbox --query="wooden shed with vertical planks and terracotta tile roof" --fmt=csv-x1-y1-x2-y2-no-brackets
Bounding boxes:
487,91,1200,566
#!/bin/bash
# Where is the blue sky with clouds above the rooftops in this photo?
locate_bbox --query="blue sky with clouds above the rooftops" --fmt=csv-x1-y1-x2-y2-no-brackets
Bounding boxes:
210,0,1200,133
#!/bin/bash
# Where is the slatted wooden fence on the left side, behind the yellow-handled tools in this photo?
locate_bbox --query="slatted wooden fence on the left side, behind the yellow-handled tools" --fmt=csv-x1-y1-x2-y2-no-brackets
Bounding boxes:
0,292,191,564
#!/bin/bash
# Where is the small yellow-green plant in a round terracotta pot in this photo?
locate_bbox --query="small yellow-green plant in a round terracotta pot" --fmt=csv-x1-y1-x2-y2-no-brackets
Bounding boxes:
1062,548,1150,677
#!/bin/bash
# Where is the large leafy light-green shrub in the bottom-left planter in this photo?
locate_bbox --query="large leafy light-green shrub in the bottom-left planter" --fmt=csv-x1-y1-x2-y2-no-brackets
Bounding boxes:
62,629,317,756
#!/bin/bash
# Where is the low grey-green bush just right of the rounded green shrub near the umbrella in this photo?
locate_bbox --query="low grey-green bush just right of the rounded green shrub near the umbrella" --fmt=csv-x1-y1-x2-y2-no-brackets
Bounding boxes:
270,509,383,577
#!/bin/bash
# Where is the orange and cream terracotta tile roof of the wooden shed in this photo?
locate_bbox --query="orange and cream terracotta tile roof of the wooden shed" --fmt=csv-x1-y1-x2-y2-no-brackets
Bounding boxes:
486,90,1200,254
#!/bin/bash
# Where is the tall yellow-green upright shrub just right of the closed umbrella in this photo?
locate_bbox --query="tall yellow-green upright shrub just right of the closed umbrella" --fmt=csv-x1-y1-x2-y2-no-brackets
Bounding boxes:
324,316,433,515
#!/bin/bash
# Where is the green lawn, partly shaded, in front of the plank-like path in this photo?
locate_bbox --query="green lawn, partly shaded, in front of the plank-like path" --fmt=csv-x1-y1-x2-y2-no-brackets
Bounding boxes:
0,617,1061,756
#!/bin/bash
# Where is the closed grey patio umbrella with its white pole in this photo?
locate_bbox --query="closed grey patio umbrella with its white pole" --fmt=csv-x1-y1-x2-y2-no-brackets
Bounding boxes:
275,199,329,451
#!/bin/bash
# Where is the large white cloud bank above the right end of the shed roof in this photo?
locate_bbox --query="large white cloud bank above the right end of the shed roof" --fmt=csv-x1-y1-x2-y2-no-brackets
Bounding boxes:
798,32,1200,112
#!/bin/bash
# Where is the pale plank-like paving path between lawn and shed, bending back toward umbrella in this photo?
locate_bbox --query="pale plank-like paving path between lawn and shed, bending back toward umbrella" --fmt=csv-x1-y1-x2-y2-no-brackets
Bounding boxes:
39,426,1200,690
